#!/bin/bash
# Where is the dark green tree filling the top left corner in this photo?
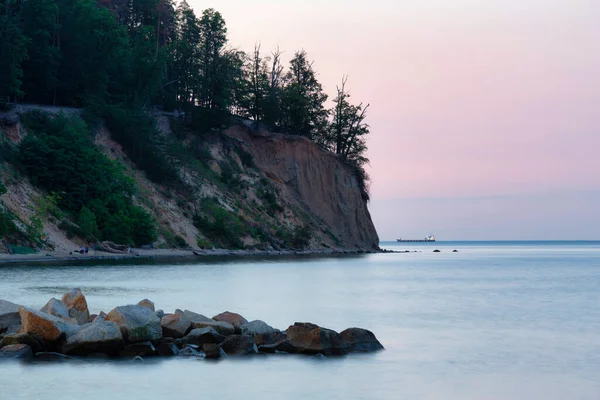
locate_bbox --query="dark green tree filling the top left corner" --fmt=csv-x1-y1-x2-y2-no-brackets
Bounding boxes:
0,0,28,99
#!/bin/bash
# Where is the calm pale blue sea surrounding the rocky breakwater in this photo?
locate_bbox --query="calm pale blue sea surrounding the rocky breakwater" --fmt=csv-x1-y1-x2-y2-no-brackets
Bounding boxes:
0,242,600,400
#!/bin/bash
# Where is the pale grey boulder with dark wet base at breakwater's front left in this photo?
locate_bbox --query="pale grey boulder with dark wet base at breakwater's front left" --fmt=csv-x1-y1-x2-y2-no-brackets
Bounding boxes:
63,321,124,356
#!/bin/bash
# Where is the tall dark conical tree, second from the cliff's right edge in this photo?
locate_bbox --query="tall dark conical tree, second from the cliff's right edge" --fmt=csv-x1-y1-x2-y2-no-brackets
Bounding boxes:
281,50,328,140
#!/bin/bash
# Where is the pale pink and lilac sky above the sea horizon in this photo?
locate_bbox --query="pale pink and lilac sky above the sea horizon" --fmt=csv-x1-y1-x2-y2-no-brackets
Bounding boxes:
188,0,600,240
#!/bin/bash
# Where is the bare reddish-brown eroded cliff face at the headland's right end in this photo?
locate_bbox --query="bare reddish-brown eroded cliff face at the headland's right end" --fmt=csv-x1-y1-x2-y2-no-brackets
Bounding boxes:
227,126,379,250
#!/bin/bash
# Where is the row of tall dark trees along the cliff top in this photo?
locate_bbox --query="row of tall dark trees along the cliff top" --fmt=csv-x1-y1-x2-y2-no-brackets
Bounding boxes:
0,0,369,196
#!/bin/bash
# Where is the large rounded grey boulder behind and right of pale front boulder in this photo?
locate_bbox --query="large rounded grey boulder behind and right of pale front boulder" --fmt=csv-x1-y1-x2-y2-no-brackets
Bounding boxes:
104,305,162,343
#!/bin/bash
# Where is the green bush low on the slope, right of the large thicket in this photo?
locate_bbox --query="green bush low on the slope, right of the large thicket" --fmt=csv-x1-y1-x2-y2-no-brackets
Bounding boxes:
194,199,249,249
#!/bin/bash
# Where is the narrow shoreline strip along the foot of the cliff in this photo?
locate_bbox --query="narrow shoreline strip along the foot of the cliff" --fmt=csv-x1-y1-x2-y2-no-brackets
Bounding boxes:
0,249,384,265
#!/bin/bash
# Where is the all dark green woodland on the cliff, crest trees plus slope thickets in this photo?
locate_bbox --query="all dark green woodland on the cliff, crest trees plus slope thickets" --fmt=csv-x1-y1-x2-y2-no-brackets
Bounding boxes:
0,0,376,247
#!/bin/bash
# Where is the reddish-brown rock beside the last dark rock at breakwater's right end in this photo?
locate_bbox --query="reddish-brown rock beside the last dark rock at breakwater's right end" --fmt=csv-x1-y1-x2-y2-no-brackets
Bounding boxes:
286,322,348,355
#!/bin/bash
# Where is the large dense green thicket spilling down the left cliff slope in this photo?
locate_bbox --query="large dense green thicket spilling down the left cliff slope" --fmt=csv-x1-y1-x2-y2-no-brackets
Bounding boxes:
19,113,156,245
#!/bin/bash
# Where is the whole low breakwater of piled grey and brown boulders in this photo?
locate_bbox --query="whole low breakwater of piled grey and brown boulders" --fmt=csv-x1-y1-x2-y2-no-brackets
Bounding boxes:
0,289,383,361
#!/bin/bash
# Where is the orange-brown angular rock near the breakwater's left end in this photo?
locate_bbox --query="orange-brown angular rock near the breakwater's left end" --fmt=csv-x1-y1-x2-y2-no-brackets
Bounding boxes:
19,307,78,342
